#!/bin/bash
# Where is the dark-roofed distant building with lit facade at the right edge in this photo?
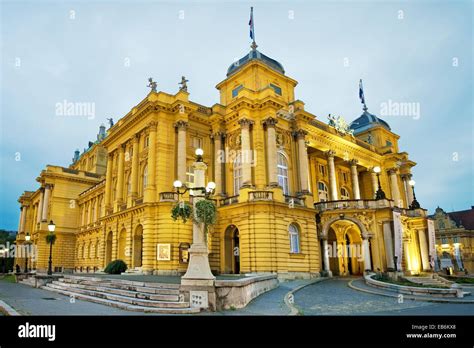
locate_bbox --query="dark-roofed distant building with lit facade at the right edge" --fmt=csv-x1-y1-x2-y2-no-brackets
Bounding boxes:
431,206,474,273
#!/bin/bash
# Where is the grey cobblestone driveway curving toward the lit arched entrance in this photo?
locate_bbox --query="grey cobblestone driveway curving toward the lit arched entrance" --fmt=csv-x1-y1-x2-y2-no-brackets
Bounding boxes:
295,278,474,315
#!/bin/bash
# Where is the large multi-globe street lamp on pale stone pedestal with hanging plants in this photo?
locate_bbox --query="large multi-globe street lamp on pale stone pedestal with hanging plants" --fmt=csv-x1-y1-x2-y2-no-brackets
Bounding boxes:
173,149,216,296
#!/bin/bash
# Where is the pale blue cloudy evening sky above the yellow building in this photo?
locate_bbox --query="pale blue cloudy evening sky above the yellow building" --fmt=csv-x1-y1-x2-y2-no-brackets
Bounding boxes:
0,0,474,230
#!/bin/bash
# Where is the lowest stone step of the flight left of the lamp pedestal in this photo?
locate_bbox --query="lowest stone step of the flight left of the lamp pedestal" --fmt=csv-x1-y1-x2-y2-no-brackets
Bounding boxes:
42,286,200,314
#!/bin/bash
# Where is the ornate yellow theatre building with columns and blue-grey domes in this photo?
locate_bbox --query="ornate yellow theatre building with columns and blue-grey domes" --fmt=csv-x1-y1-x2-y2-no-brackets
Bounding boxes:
13,40,435,278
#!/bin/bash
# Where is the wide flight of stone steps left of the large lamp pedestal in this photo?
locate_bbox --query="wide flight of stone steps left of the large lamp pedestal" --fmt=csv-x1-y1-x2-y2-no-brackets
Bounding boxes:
42,275,200,314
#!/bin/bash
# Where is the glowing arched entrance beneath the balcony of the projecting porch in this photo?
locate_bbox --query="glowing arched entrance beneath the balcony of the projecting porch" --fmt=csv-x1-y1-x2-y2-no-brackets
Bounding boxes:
327,219,364,276
